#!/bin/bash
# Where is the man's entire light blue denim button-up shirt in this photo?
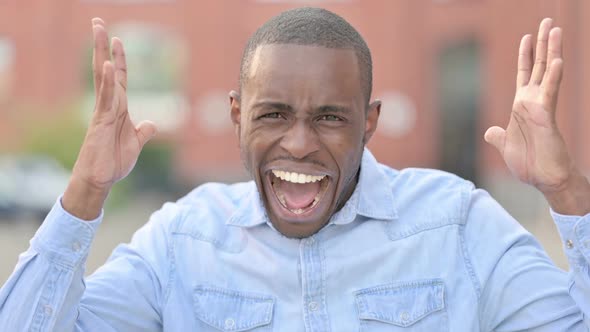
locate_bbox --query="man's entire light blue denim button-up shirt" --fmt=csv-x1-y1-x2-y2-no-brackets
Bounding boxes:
0,151,590,332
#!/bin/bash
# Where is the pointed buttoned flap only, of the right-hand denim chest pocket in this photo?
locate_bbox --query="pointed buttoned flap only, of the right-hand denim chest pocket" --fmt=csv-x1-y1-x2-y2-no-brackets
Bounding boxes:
355,279,445,327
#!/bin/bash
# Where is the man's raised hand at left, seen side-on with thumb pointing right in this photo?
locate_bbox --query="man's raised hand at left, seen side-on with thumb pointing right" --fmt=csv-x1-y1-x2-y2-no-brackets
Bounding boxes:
62,18,156,219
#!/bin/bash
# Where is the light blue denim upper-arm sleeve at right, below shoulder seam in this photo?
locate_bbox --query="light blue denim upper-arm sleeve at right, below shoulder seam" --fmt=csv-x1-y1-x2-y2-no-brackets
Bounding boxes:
464,190,590,331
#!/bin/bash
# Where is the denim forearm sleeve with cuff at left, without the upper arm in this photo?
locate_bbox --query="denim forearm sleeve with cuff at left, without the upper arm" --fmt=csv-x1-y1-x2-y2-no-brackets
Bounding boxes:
0,199,103,331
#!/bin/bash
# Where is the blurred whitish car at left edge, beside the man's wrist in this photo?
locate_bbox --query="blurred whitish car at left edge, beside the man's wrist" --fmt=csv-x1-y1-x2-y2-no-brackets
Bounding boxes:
0,155,70,221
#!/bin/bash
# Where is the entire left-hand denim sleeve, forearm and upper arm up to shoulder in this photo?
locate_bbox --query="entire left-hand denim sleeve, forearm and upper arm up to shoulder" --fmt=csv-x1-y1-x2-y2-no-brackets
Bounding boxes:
0,196,173,331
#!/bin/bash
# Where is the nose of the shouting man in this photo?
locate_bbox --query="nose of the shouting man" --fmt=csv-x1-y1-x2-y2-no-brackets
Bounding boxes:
280,120,319,159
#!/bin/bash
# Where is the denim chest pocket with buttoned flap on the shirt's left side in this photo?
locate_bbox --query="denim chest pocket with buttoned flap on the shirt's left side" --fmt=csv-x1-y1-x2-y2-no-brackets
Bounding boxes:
193,286,274,332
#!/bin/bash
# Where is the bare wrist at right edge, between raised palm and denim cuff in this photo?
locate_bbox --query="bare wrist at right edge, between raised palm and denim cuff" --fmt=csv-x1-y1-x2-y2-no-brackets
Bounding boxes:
543,169,590,216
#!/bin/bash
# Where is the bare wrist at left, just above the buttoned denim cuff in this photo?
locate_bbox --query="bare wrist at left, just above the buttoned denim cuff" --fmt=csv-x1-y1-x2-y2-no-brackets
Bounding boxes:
61,176,110,220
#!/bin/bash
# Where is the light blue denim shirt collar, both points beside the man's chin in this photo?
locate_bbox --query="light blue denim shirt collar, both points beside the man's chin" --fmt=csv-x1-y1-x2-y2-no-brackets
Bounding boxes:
226,148,397,227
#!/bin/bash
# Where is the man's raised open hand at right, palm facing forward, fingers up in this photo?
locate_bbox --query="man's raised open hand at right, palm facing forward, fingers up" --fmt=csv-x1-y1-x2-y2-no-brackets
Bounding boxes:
485,18,590,214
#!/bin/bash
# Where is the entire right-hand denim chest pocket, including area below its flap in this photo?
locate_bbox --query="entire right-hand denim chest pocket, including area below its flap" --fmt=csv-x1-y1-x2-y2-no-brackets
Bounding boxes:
355,279,449,331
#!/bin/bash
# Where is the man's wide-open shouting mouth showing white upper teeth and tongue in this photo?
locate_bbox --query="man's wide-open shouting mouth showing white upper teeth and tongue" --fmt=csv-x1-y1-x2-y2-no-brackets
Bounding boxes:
269,170,329,215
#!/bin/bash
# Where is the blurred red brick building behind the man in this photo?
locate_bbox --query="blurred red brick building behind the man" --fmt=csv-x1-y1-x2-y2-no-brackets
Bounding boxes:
0,0,590,208
